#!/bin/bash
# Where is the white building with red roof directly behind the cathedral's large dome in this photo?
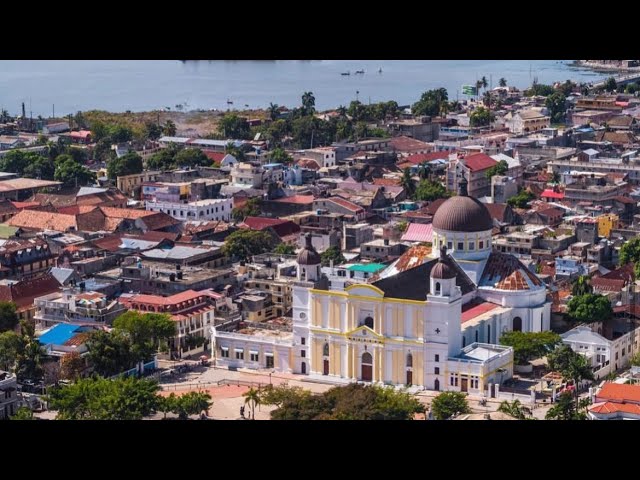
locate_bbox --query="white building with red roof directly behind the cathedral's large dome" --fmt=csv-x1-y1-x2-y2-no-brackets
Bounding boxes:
446,153,498,198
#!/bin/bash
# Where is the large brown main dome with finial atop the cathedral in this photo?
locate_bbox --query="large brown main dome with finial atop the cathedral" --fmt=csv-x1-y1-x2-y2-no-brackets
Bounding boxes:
433,179,493,232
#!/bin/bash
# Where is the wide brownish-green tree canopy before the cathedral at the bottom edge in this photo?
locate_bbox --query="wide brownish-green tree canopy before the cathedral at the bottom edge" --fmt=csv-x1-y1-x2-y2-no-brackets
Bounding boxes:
262,383,424,420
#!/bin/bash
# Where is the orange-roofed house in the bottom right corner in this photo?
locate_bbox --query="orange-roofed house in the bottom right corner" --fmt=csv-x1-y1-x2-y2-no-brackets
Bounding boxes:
589,382,640,420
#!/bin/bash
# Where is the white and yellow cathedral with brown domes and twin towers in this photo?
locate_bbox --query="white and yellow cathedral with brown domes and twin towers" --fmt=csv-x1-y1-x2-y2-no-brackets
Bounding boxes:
290,181,551,395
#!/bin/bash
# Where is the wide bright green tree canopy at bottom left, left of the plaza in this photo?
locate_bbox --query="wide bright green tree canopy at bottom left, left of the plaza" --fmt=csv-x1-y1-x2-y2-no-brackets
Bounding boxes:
49,377,159,420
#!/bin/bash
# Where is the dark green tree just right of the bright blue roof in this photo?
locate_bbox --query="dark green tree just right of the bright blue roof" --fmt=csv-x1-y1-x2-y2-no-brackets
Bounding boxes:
87,330,135,377
